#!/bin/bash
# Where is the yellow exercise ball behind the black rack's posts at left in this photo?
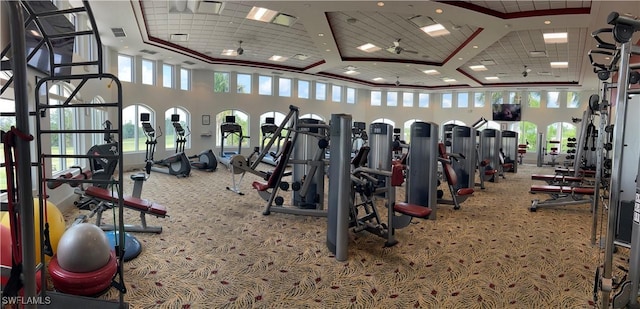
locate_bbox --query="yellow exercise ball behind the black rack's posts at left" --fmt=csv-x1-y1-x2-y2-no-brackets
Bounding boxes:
0,198,67,263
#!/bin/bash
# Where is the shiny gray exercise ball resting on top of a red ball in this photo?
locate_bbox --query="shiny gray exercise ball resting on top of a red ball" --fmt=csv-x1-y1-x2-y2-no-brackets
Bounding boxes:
57,223,111,273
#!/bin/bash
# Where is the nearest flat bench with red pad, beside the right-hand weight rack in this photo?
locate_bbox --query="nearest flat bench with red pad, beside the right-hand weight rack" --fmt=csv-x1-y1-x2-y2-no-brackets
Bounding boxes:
529,185,595,212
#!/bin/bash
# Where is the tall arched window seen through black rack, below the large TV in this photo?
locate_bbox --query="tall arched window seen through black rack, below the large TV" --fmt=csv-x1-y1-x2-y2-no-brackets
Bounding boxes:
49,82,82,174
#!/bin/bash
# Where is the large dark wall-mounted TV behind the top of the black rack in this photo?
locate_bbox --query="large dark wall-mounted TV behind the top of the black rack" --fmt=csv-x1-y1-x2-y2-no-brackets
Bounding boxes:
23,1,75,75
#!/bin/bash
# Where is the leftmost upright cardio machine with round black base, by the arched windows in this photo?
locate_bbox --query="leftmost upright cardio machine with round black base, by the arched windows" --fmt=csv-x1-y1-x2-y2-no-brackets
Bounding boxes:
140,113,191,177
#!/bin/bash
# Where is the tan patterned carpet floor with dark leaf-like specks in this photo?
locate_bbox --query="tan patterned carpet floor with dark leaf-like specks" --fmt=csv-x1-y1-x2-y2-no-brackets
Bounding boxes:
57,165,602,308
